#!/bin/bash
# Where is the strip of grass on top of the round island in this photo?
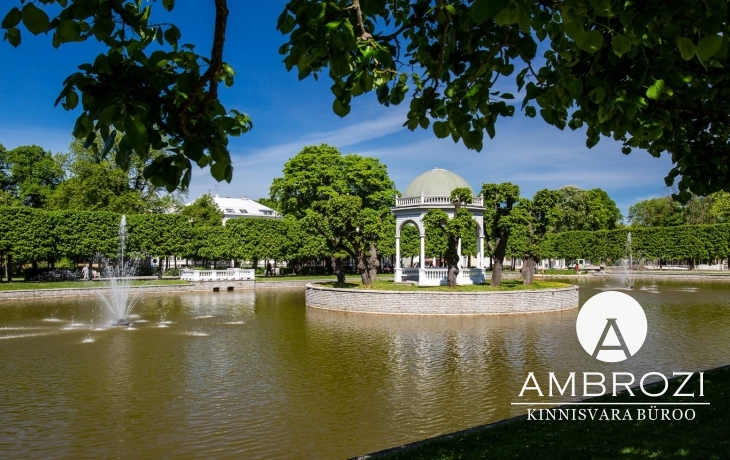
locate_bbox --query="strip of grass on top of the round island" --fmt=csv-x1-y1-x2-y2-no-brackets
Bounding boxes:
319,277,573,292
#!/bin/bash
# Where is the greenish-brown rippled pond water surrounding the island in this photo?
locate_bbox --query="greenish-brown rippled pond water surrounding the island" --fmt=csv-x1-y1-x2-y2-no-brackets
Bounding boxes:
0,279,730,459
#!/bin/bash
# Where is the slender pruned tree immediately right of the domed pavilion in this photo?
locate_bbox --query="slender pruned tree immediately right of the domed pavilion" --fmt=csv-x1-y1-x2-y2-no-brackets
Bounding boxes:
482,182,520,286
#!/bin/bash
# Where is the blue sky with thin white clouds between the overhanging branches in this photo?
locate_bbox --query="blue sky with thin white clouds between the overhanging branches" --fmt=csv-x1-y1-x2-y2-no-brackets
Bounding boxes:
0,0,671,215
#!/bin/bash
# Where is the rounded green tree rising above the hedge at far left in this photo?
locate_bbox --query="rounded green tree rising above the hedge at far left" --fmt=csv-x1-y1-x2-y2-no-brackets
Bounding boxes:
6,145,63,208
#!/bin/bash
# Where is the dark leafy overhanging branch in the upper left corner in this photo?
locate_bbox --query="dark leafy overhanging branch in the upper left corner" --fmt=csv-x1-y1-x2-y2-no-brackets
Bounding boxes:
2,0,252,191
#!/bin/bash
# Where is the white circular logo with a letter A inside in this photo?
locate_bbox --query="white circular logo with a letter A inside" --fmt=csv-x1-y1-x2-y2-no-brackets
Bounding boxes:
575,291,647,363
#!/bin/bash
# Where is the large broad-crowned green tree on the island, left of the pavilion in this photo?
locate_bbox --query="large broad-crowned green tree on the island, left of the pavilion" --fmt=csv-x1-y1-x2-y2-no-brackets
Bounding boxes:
270,144,396,284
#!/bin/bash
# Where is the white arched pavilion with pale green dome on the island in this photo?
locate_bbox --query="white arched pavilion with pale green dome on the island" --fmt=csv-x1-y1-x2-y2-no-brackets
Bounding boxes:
391,168,485,286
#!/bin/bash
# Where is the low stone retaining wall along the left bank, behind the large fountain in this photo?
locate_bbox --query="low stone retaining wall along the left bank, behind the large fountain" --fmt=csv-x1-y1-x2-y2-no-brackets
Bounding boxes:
0,280,256,300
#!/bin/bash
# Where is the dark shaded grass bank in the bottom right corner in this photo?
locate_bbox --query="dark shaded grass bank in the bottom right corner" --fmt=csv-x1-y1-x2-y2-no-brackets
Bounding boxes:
374,367,730,460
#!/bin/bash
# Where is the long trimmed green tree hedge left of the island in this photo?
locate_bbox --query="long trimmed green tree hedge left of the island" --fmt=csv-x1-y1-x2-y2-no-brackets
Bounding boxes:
0,207,322,278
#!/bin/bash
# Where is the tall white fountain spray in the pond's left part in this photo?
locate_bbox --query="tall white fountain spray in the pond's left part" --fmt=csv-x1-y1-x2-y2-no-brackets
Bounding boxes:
101,216,139,326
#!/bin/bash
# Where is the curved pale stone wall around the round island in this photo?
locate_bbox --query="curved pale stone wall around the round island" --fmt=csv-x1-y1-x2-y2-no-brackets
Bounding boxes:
305,284,578,315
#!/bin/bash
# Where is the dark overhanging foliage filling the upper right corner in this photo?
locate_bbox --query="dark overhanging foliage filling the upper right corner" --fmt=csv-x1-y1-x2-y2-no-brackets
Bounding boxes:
278,0,730,200
